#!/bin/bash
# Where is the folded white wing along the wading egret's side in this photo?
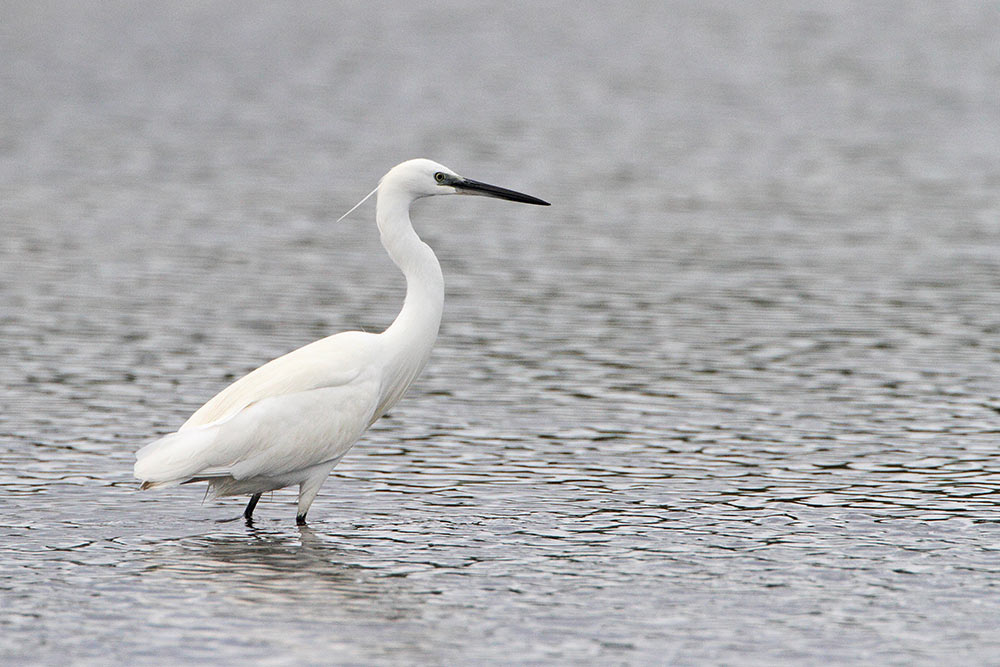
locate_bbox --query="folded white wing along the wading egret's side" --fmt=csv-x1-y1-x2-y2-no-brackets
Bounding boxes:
135,332,380,488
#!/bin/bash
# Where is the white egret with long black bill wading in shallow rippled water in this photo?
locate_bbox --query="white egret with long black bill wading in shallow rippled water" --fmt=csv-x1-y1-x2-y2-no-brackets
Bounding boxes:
135,159,548,525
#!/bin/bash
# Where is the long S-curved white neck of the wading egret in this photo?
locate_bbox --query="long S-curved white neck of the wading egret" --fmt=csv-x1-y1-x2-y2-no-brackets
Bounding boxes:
375,188,444,370
